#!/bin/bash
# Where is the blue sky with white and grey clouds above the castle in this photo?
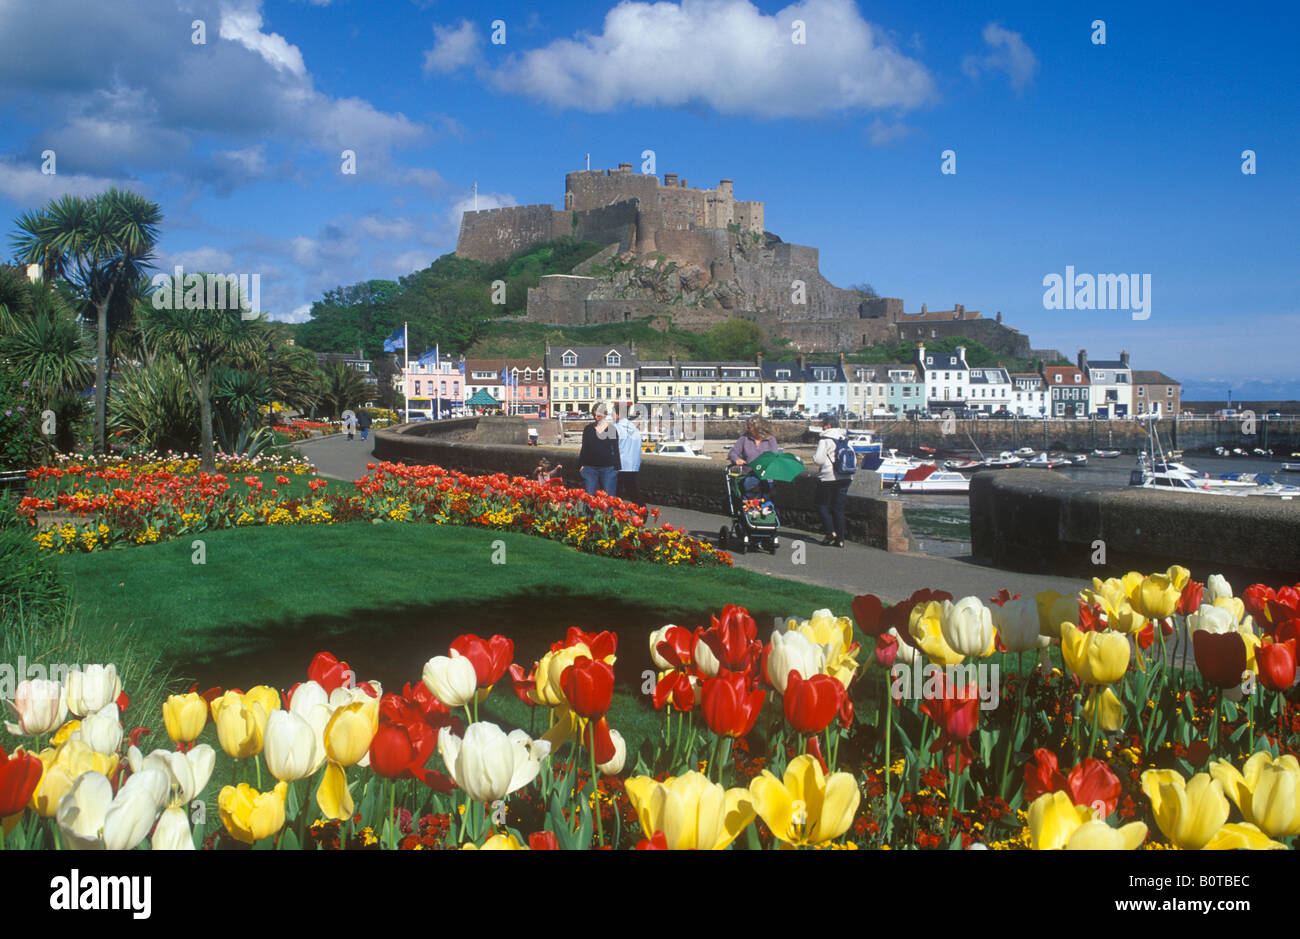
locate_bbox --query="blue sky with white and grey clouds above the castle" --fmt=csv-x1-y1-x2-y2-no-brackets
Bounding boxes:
0,0,1300,397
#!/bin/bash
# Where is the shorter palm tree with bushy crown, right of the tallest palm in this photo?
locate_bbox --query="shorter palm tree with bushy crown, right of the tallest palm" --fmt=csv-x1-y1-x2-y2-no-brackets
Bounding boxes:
143,274,259,472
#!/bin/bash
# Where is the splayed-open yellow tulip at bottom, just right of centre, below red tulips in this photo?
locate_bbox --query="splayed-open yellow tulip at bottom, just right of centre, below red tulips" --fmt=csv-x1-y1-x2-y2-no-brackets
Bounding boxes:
749,753,862,845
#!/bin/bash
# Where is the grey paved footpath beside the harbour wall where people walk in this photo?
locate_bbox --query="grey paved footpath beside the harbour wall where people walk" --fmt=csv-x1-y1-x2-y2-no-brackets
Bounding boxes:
289,434,1089,602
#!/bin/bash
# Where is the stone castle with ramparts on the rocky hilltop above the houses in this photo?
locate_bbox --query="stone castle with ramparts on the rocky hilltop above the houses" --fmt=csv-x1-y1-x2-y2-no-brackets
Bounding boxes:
456,163,1050,355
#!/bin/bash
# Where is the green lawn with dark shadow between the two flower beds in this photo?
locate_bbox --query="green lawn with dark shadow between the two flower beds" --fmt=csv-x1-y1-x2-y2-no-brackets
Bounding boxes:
59,522,850,748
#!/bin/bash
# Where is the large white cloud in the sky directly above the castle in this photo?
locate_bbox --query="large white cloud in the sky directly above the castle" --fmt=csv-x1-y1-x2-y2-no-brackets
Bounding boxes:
485,0,933,117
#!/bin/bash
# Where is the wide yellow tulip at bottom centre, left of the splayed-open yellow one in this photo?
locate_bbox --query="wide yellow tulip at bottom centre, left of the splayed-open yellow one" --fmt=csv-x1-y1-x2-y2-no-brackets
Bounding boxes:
625,770,754,851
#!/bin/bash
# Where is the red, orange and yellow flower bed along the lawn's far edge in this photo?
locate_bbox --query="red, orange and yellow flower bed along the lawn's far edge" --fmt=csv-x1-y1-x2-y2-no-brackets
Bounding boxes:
18,455,731,566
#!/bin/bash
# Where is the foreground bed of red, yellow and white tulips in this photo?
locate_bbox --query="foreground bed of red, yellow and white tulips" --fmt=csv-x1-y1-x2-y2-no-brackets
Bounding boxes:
0,567,1300,849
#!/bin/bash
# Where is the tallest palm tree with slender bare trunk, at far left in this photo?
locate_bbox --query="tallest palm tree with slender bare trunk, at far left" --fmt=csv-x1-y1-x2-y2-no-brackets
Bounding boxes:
13,189,163,453
